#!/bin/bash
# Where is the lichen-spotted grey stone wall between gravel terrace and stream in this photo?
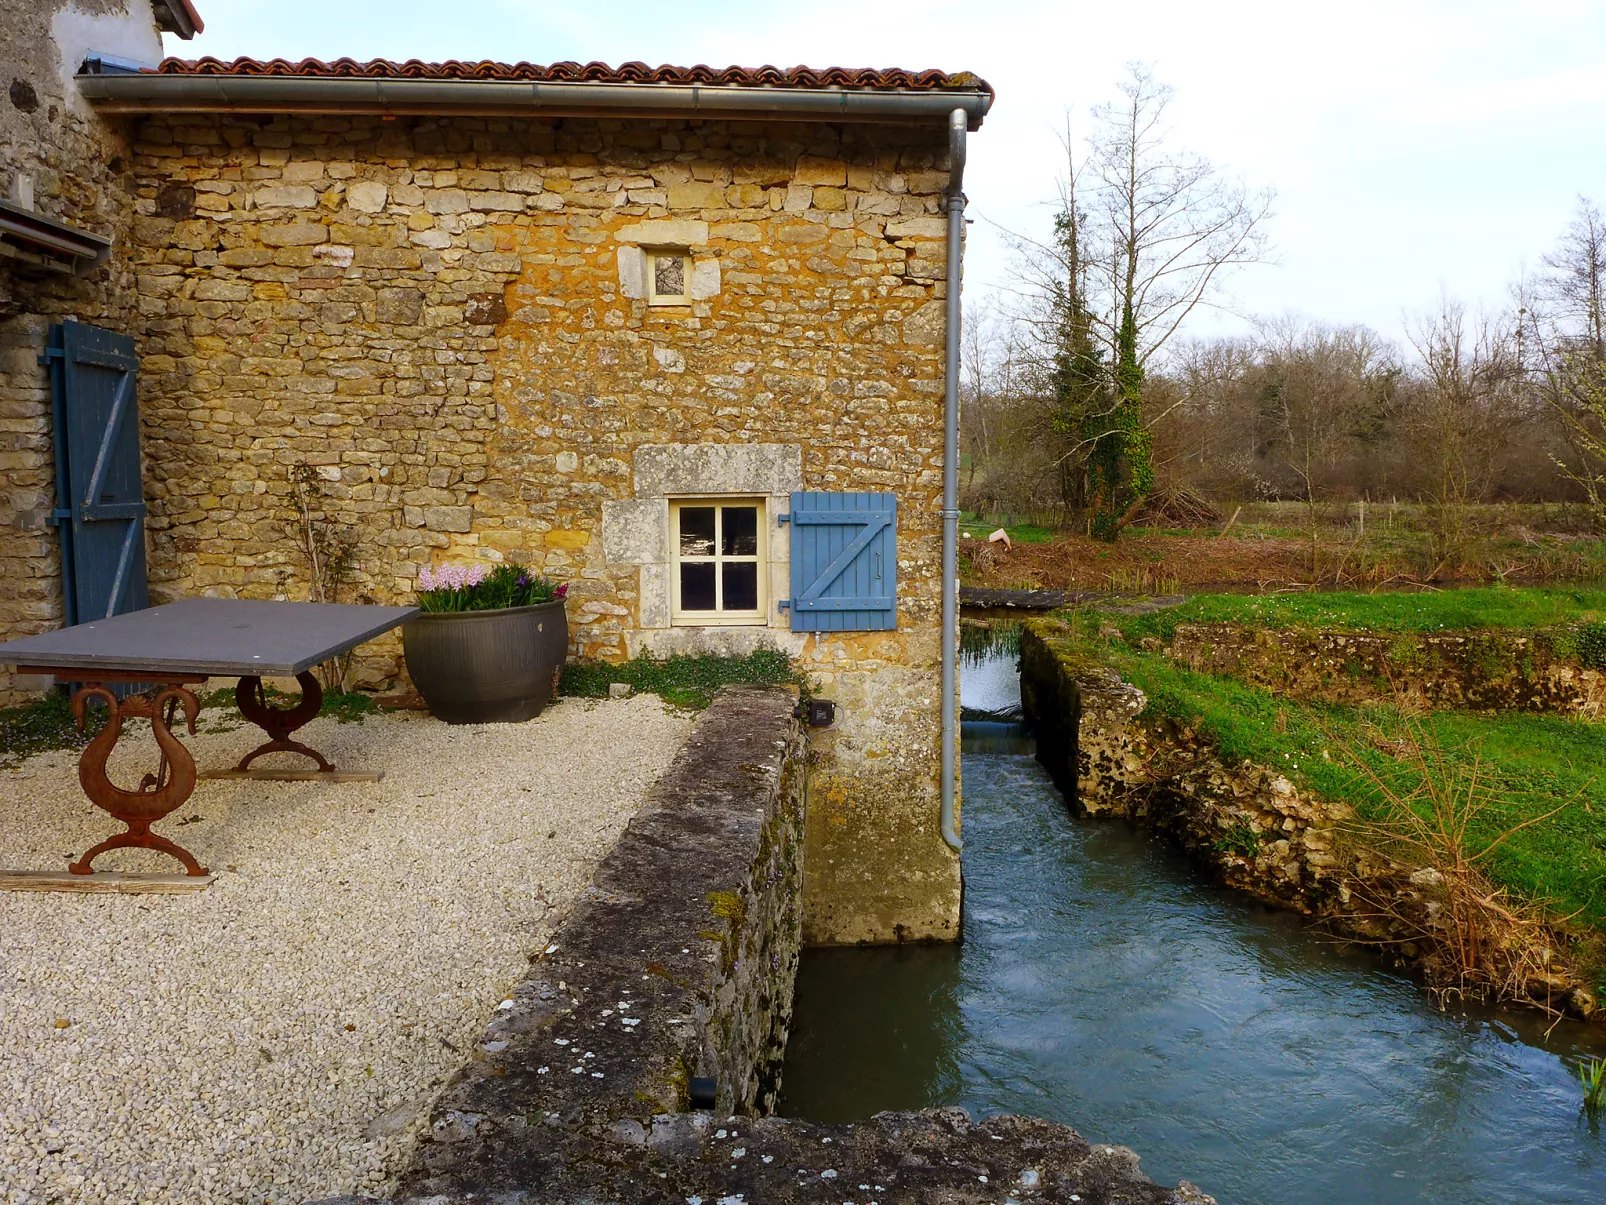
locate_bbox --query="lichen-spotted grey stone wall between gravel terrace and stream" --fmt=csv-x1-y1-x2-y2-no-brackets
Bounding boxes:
309,686,1211,1205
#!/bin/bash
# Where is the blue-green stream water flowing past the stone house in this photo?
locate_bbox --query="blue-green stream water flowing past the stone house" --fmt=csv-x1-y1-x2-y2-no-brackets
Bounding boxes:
782,656,1606,1205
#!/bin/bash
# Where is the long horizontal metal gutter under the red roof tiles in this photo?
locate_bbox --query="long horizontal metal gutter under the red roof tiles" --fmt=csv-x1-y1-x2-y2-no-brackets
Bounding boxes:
75,72,993,129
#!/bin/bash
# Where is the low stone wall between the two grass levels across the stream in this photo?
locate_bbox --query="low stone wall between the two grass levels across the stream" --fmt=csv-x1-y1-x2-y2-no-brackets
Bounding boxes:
1171,623,1606,717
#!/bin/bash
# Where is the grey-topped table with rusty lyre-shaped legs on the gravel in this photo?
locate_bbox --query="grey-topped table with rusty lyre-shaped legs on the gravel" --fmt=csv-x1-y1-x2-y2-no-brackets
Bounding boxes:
0,598,418,879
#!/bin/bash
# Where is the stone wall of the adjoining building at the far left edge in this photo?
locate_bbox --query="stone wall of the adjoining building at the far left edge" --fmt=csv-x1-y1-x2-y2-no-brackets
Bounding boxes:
0,0,162,704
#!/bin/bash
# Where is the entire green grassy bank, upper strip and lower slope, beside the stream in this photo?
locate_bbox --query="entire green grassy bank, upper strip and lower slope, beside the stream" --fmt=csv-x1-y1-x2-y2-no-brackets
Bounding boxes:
1040,590,1606,988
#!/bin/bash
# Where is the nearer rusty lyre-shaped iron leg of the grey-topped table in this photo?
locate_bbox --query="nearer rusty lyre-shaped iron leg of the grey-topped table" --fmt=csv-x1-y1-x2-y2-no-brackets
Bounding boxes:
67,683,207,876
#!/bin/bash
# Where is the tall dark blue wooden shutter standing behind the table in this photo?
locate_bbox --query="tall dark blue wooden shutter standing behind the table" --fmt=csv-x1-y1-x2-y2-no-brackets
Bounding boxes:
45,320,149,625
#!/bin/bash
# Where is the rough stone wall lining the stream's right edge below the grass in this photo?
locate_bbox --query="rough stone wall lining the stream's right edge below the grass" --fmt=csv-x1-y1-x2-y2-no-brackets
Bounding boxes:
1021,620,1598,1017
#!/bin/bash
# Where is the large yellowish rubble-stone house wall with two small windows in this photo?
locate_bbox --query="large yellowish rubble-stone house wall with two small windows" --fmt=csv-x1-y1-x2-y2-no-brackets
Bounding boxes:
122,108,959,942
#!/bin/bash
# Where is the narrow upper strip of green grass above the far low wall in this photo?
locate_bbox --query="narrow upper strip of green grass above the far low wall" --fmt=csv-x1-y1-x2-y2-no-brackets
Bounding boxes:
1110,586,1606,643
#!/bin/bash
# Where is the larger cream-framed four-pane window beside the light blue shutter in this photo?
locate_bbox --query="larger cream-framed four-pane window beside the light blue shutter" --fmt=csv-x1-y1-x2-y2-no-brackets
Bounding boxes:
670,498,768,623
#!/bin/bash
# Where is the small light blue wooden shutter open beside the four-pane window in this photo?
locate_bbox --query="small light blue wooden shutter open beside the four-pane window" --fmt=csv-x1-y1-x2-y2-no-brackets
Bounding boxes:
789,492,898,631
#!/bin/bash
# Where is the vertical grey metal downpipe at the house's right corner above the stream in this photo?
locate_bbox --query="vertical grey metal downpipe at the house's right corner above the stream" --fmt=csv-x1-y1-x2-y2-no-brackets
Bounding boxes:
943,109,968,852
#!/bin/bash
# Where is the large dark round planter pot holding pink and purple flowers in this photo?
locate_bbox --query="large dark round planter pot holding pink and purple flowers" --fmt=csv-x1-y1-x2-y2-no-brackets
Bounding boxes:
402,599,569,725
